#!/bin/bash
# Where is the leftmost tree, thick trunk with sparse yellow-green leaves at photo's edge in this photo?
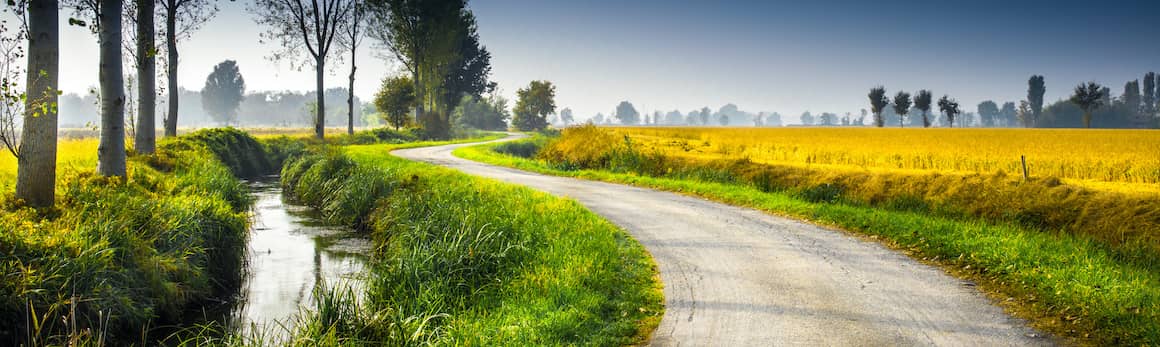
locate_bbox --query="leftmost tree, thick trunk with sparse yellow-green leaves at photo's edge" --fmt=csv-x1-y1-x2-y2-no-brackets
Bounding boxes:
0,0,60,208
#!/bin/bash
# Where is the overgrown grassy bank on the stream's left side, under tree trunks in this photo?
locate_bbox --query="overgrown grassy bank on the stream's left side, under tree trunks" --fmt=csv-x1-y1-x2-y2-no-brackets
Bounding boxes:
0,130,272,345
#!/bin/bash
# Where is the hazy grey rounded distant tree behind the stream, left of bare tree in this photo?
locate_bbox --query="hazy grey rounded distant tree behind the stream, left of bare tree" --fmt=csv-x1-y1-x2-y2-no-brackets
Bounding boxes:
202,60,246,124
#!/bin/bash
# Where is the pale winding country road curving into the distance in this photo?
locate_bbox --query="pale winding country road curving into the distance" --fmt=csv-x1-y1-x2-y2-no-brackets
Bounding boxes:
392,136,1052,346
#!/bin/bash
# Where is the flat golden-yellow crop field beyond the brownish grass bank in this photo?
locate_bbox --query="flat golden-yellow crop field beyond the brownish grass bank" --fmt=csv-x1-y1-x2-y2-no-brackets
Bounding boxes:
611,128,1160,190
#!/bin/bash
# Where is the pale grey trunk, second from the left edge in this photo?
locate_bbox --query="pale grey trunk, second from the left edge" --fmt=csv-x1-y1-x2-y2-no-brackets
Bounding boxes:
96,0,125,178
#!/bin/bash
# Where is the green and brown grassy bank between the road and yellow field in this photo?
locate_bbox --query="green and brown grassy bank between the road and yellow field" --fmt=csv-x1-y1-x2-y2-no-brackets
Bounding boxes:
456,129,1160,345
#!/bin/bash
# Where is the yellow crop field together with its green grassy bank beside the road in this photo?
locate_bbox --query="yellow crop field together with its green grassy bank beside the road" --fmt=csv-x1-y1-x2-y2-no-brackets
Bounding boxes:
456,126,1160,345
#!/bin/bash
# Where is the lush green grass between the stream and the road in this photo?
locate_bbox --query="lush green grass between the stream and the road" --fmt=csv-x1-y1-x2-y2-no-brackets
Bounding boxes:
265,144,664,346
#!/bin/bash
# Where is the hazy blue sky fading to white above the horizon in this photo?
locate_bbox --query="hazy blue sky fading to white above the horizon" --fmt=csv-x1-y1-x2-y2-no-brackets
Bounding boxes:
33,0,1160,122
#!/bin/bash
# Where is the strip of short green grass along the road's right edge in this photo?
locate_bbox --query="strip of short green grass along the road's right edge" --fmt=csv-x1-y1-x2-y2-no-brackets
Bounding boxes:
455,135,1160,345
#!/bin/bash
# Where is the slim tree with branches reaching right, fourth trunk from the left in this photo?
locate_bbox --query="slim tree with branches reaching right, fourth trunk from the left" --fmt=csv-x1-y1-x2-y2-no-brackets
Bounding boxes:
159,0,218,136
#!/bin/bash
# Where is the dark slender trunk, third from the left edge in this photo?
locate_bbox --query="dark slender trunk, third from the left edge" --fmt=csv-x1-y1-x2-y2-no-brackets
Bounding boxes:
135,0,157,154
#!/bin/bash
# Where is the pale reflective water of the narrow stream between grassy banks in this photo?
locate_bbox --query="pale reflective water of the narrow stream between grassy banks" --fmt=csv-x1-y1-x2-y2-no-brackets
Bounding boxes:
229,178,370,338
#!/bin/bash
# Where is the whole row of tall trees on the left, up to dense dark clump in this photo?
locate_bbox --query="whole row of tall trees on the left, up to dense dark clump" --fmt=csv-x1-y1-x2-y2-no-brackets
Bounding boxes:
0,0,494,207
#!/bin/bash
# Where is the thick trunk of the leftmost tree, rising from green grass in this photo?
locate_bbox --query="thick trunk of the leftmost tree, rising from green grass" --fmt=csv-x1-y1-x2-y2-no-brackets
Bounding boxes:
16,0,60,208
